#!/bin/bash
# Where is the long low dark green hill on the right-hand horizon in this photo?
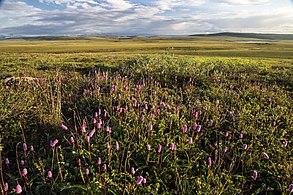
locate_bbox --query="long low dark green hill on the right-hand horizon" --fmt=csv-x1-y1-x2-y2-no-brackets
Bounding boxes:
191,32,293,40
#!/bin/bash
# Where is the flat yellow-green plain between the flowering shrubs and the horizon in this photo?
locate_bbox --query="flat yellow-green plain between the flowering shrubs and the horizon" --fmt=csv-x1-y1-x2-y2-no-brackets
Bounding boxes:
0,36,293,59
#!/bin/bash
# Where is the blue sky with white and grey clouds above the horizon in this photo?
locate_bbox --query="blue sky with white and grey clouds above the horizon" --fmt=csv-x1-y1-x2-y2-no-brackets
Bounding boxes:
0,0,293,36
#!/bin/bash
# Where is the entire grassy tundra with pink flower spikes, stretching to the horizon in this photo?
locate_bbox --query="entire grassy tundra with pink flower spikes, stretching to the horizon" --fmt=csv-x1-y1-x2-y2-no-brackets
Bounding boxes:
0,36,293,194
